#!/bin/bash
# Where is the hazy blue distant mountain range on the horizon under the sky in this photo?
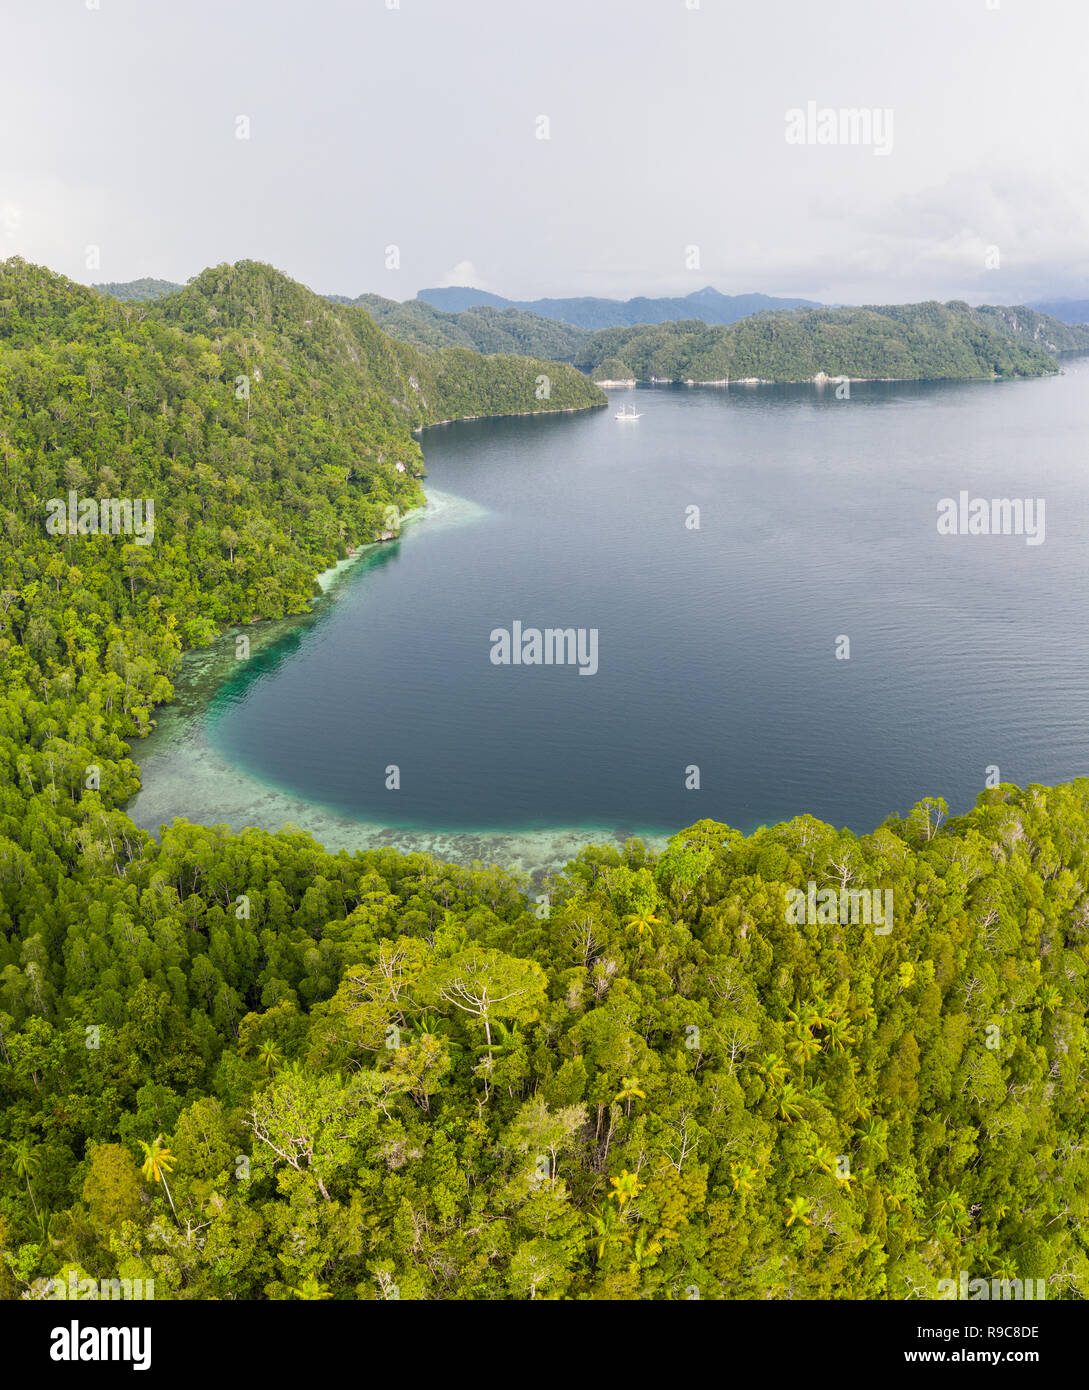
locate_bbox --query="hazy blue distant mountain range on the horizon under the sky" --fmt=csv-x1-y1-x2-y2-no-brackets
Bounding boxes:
416,285,825,332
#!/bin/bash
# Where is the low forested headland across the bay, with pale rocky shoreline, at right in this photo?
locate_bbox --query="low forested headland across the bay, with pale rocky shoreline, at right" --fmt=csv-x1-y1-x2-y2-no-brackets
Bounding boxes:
574,302,1089,382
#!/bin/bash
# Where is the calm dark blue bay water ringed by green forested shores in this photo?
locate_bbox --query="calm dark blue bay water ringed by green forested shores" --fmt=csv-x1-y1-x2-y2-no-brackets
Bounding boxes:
206,360,1089,833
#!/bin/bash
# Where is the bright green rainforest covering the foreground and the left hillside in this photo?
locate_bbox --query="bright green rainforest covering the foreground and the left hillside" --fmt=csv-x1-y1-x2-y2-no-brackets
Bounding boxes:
0,261,1089,1300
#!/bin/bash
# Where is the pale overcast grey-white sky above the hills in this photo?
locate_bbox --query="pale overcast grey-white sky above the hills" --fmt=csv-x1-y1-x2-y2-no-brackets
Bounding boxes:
0,0,1089,303
